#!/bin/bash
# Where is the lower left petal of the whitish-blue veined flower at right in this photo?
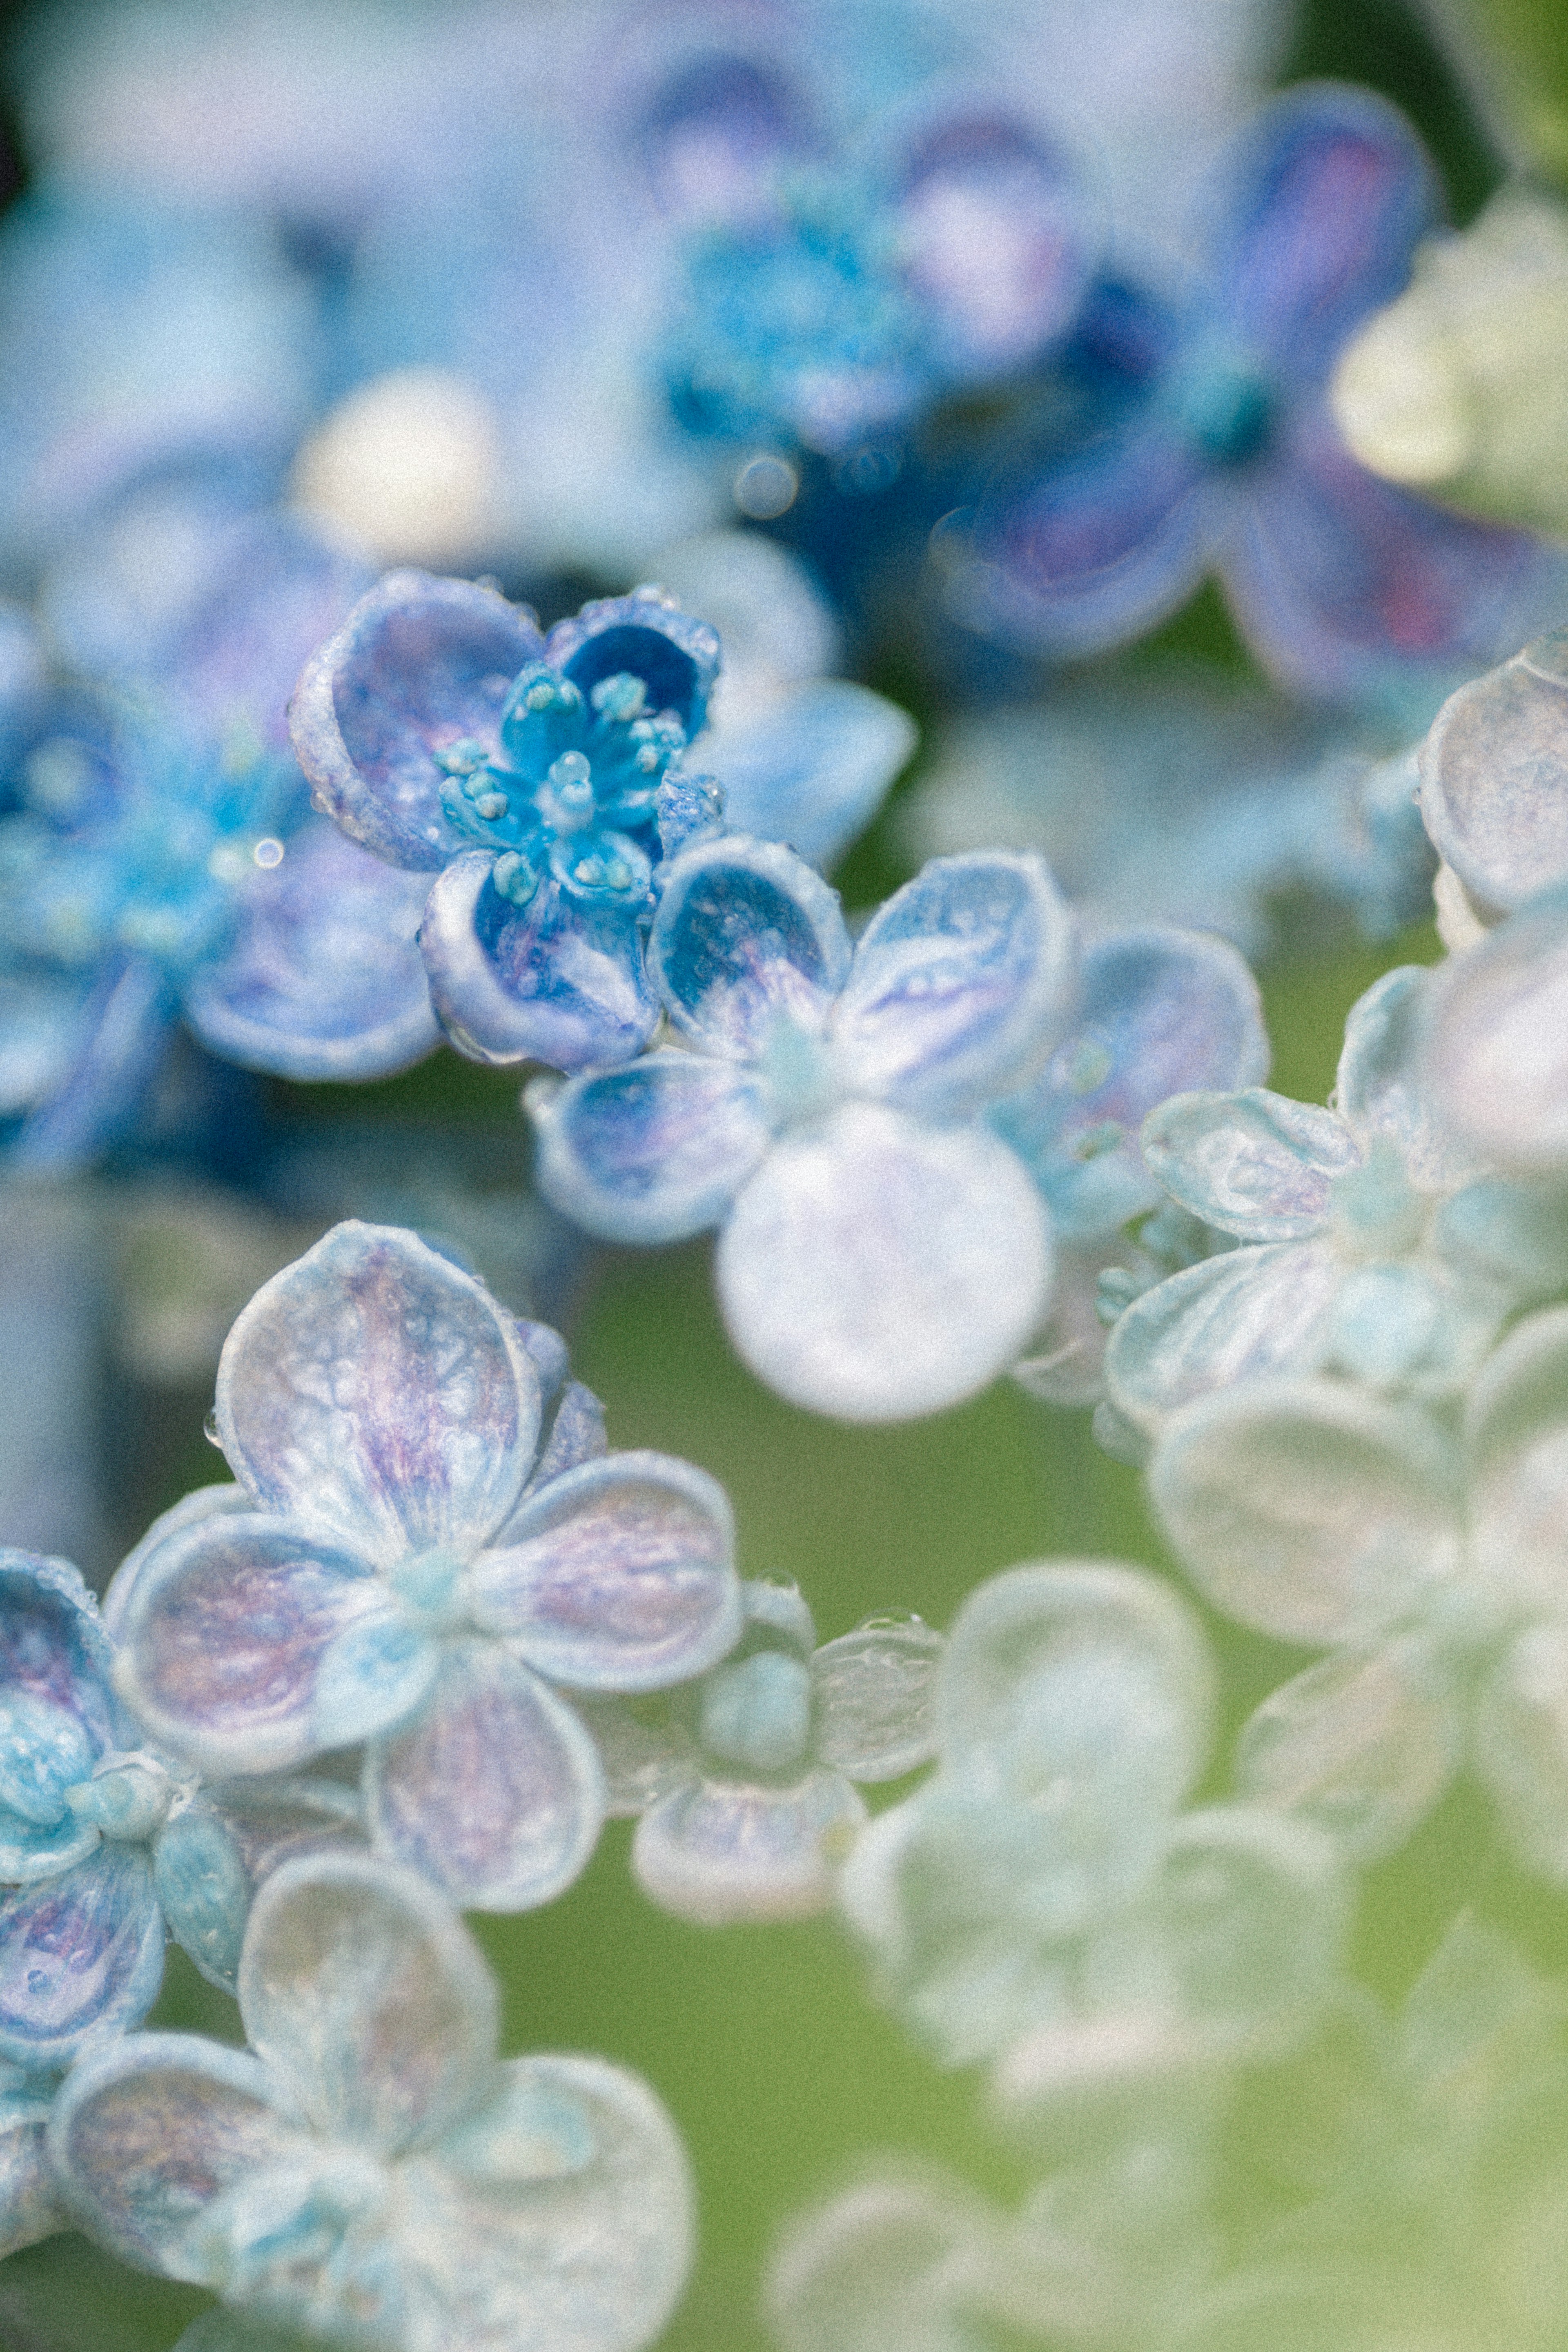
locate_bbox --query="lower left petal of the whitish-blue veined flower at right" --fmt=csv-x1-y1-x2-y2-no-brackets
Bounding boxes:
1105,1242,1345,1432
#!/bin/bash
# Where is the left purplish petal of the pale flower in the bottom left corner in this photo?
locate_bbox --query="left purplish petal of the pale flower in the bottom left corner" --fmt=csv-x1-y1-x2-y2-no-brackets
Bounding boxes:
49,2034,301,2281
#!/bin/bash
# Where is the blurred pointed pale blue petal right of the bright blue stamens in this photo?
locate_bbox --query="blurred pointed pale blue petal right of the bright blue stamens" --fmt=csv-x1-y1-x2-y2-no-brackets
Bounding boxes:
710,677,919,870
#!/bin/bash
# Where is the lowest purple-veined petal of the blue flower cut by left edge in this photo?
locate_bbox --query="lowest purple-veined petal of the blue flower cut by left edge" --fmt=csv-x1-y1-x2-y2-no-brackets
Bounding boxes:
0,1844,165,2074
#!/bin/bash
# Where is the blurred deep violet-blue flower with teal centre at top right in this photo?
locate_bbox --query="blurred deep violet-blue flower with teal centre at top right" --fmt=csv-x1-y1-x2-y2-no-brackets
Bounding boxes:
957,85,1566,701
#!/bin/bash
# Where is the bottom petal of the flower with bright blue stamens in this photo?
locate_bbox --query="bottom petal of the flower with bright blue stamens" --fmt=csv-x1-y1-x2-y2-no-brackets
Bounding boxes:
421,849,658,1070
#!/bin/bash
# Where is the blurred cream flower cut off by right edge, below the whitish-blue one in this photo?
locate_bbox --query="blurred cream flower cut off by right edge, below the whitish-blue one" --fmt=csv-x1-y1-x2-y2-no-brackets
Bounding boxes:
1149,1308,1568,1882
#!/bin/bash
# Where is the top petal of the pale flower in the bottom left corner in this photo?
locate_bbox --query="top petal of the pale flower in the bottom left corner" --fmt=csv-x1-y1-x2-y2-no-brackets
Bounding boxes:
240,1853,501,2157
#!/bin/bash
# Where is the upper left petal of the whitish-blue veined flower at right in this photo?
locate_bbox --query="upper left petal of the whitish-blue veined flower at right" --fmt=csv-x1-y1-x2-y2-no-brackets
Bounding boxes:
1143,1087,1361,1242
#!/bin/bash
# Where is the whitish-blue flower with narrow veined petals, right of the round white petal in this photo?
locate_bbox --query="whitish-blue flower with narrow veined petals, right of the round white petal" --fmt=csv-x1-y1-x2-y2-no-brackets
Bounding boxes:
1105,964,1561,1432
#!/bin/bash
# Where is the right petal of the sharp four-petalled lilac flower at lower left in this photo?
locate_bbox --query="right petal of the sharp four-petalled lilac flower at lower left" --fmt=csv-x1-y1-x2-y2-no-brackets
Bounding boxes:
463,1454,743,1691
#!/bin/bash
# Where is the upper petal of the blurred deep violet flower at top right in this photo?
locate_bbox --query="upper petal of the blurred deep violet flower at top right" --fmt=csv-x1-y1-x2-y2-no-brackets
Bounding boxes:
1215,85,1441,379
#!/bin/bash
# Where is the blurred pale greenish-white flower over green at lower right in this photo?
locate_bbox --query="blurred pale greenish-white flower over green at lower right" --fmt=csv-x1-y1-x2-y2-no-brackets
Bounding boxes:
842,1564,1342,2114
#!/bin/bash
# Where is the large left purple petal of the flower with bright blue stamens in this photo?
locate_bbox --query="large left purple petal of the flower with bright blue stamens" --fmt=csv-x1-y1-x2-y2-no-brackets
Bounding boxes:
289,572,543,873
